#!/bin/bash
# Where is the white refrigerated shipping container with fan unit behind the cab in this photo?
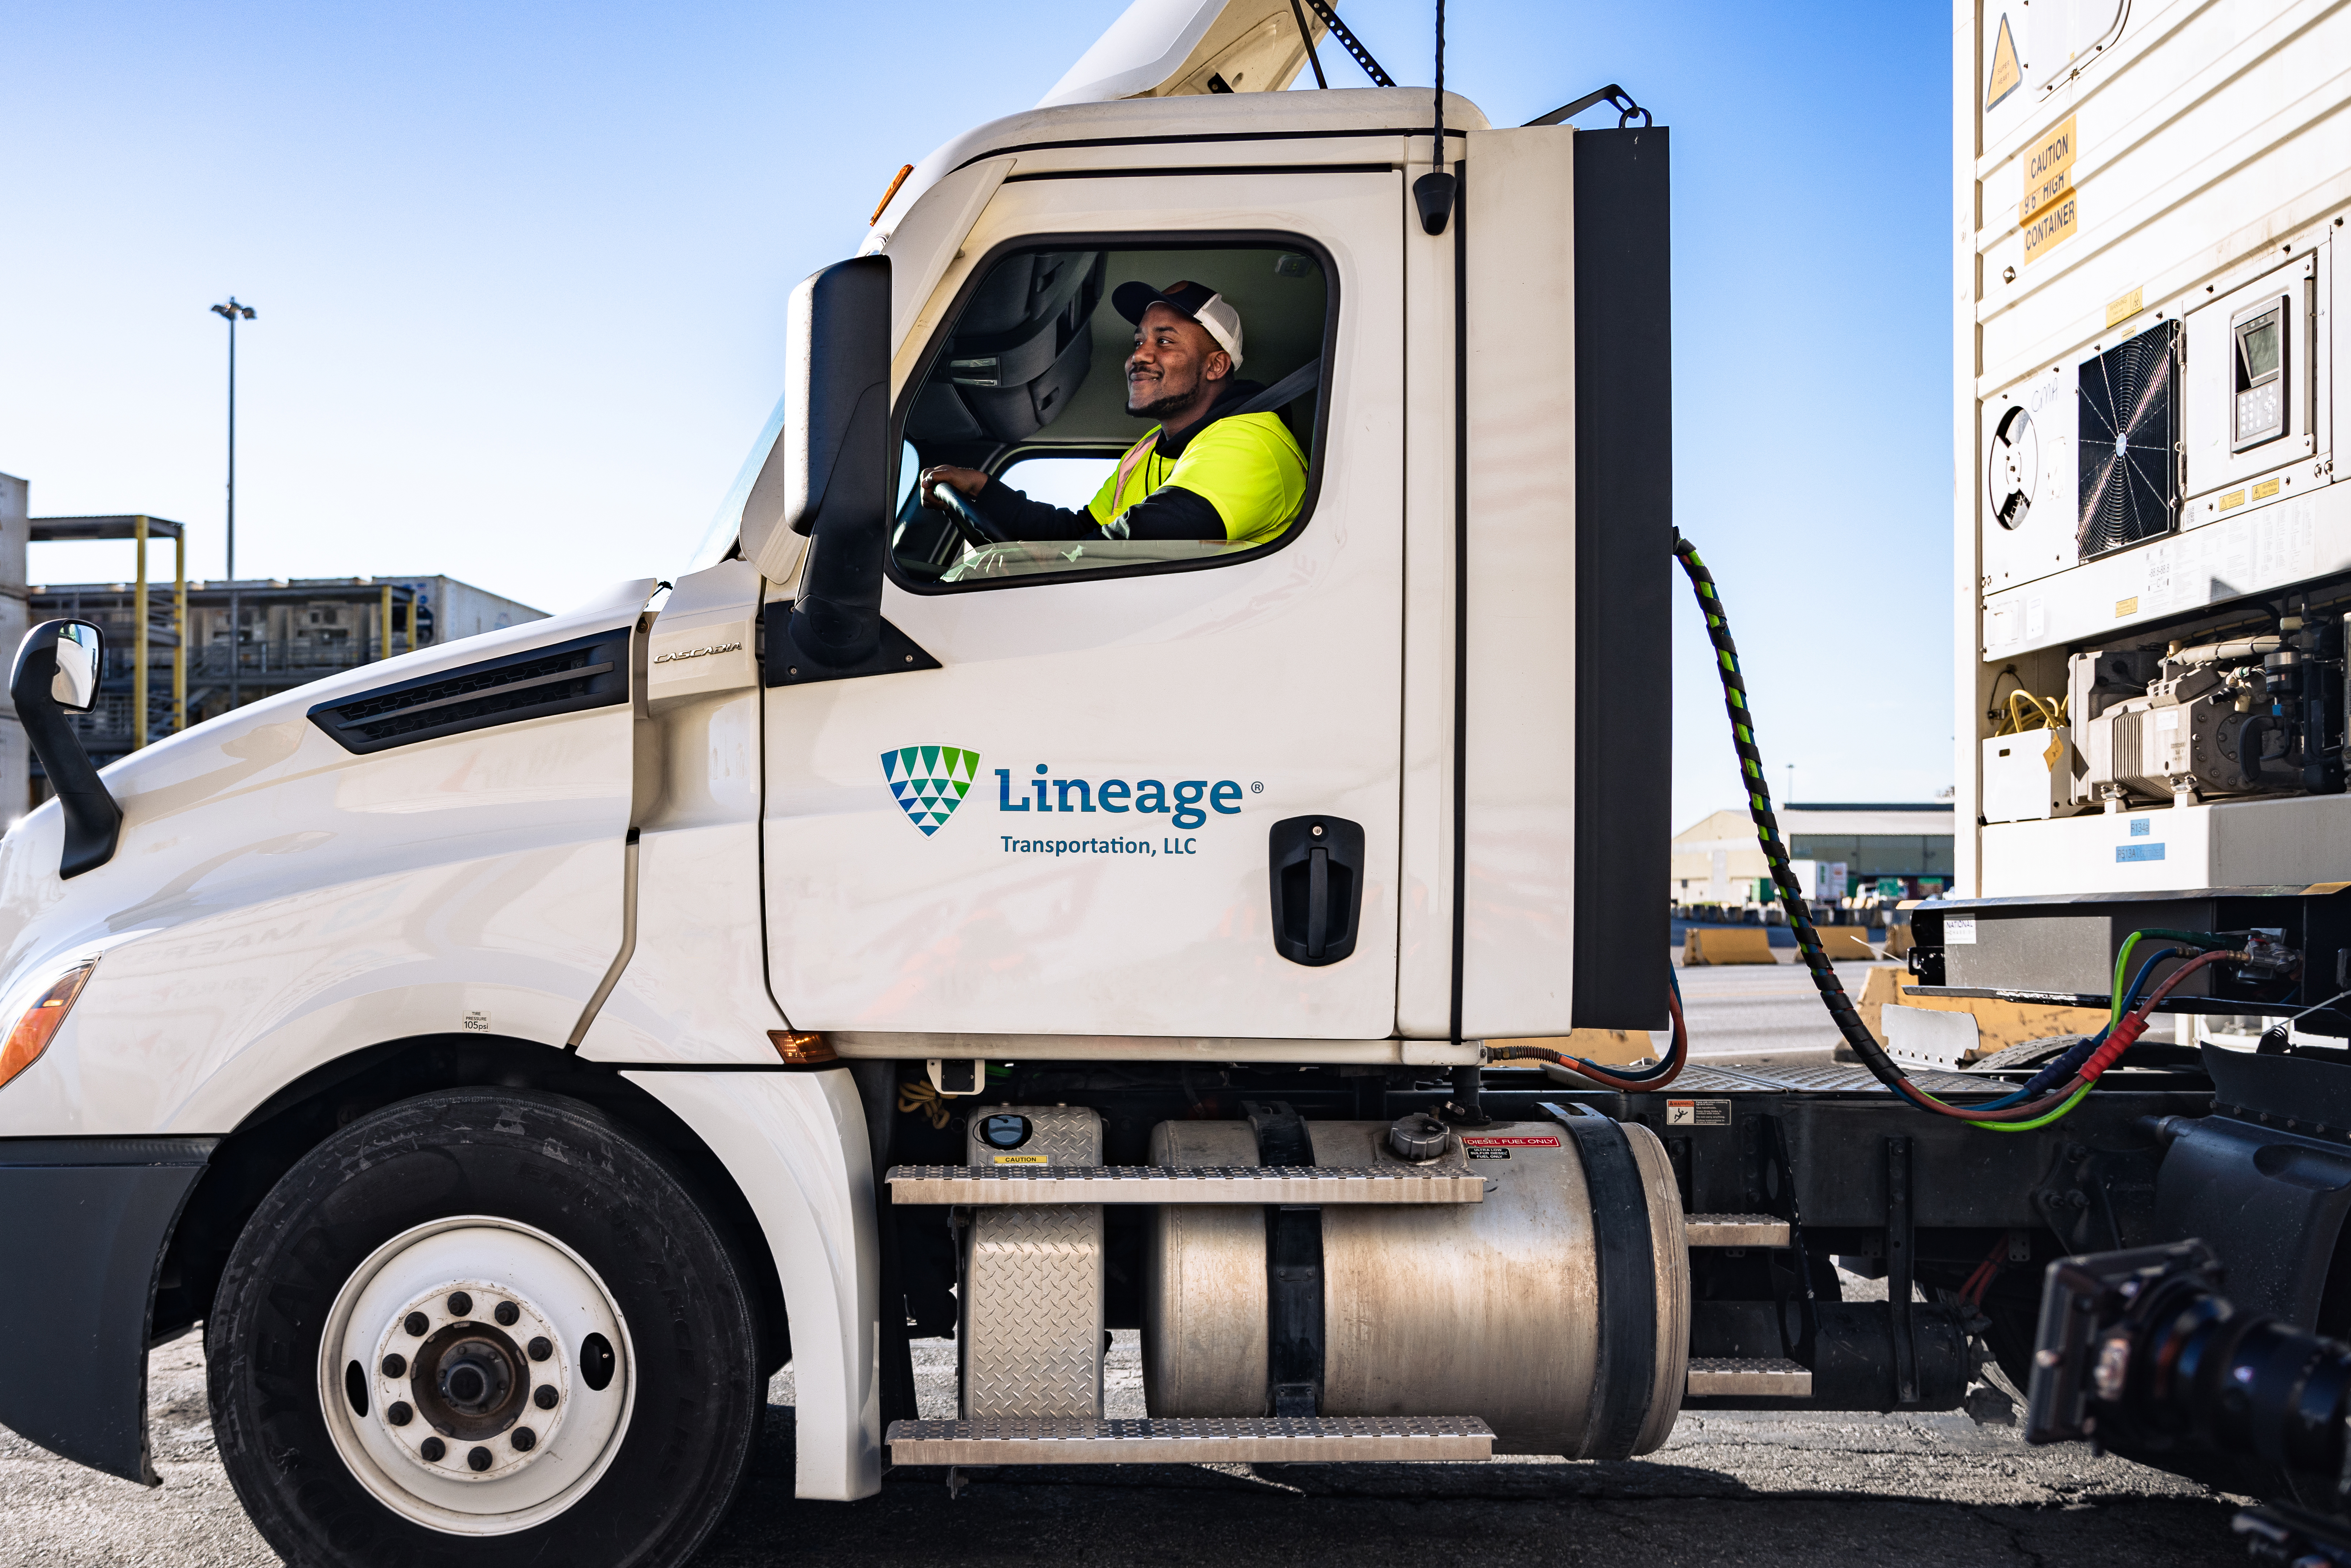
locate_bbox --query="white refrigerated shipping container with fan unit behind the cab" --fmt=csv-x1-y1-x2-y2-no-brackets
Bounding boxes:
1954,0,2351,896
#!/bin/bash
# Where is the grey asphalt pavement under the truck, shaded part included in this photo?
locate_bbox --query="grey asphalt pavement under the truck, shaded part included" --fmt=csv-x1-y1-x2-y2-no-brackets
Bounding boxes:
0,1333,2240,1568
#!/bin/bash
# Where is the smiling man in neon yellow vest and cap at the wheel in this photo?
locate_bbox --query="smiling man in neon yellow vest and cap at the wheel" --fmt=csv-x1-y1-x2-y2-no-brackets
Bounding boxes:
919,282,1307,543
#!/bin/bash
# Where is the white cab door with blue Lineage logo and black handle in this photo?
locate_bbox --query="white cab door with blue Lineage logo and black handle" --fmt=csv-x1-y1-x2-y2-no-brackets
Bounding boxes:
764,164,1408,1053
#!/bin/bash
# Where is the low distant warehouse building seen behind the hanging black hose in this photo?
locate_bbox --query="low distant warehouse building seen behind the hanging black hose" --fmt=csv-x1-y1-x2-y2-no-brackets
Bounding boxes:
1672,802,1956,905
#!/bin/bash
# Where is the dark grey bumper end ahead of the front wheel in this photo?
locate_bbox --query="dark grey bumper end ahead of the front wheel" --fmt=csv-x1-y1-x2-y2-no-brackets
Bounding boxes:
0,1138,219,1486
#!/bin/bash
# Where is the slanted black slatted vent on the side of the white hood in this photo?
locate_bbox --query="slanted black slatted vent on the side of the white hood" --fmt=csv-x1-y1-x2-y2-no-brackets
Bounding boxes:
310,625,630,755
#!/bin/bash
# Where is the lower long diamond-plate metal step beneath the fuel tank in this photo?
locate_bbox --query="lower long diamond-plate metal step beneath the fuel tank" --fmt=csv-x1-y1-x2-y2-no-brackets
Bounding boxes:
882,1415,1493,1465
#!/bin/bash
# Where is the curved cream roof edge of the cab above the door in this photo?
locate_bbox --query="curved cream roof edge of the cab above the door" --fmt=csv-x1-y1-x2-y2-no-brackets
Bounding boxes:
858,87,1491,256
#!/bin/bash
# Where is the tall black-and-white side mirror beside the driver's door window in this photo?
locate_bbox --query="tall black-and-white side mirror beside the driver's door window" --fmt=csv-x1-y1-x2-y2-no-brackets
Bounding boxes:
743,256,903,679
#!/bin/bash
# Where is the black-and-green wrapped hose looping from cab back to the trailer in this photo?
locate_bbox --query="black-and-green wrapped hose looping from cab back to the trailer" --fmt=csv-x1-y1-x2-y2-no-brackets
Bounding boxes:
1674,533,2245,1133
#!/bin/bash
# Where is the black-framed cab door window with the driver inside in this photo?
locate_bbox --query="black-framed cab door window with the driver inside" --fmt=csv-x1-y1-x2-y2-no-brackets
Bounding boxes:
891,240,1335,592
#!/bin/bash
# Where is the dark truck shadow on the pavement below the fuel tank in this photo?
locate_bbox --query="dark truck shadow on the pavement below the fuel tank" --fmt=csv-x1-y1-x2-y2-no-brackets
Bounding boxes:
696,1406,2243,1568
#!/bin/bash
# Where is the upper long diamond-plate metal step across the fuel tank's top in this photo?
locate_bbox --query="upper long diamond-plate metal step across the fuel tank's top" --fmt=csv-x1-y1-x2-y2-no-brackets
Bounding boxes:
886,1166,1486,1206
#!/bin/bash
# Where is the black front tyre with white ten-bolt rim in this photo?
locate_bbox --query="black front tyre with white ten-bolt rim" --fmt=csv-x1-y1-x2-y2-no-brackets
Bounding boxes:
207,1088,764,1568
